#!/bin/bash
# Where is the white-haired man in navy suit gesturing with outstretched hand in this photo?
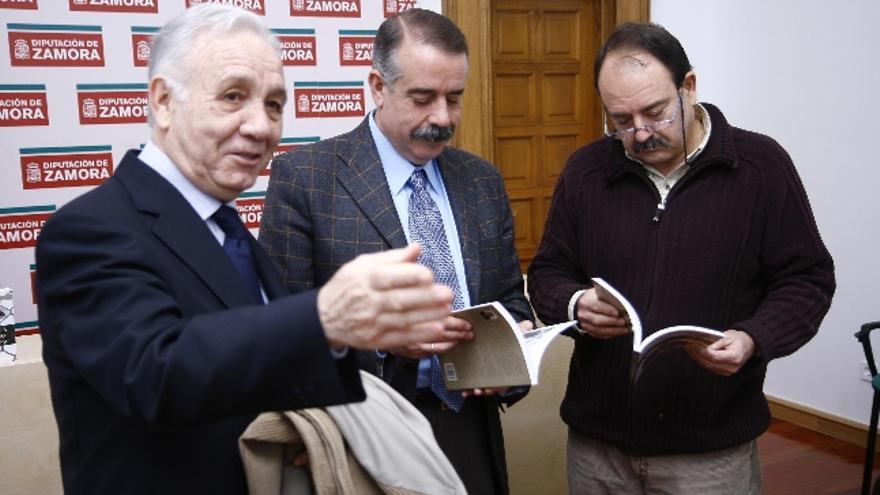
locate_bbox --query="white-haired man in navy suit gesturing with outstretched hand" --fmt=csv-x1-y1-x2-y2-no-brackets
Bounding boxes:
36,4,460,495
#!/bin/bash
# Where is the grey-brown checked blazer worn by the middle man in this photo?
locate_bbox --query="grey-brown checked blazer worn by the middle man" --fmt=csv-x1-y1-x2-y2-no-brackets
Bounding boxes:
260,119,533,494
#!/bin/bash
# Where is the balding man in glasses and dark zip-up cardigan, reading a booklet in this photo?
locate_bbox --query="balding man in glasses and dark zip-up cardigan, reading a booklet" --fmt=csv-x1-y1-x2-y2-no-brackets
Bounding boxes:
528,24,835,494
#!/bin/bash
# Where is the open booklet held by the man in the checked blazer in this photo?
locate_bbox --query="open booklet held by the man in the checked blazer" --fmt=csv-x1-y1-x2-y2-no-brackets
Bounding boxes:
439,301,575,390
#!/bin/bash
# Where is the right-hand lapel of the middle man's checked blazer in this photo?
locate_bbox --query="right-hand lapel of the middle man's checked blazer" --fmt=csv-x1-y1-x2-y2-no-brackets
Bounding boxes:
437,150,480,304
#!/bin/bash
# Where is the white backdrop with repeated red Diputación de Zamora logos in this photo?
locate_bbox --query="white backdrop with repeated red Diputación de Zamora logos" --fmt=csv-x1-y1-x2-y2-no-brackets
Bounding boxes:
0,0,441,336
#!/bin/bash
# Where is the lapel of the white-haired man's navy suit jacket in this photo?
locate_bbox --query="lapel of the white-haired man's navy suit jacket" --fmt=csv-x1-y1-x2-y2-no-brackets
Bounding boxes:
115,152,253,307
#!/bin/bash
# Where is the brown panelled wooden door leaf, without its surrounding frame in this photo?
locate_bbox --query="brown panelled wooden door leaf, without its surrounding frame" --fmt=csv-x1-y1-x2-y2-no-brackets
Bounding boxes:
491,0,602,269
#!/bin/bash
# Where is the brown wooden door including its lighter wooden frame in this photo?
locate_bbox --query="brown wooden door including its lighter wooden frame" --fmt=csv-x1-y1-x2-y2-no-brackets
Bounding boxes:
443,0,648,271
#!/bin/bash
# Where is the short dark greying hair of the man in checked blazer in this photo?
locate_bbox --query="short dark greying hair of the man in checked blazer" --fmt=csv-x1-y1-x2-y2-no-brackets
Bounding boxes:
373,9,468,86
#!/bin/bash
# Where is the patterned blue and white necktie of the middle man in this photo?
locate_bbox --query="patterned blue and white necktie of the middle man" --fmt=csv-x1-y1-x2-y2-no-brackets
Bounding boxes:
409,169,464,412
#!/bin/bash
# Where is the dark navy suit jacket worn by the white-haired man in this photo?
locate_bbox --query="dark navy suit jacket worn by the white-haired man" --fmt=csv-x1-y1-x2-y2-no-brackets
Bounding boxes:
36,152,364,494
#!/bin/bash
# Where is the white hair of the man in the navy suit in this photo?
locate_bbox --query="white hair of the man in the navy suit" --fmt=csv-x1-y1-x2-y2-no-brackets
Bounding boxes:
148,3,280,108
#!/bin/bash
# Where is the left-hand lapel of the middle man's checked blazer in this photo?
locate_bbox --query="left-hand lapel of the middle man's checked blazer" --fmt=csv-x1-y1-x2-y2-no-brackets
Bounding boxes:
336,117,406,248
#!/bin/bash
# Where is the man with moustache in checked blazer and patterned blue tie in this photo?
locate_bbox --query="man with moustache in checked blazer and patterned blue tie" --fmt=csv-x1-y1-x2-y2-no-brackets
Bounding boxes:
260,9,533,494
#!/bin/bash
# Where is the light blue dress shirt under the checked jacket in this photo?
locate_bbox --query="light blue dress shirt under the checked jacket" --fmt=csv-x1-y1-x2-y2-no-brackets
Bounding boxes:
370,113,471,388
